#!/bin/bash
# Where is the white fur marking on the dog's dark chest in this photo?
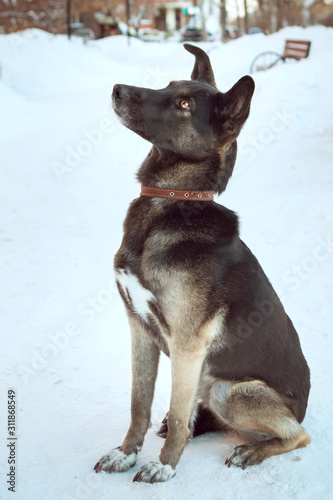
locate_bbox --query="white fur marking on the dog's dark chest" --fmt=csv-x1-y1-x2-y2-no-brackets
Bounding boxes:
116,269,155,321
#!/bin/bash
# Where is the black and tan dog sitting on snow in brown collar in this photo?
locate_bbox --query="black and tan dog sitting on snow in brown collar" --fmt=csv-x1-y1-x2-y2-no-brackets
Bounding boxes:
95,44,311,483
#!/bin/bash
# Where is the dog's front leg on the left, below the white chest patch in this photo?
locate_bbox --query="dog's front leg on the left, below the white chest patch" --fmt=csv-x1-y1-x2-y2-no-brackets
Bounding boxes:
95,315,160,473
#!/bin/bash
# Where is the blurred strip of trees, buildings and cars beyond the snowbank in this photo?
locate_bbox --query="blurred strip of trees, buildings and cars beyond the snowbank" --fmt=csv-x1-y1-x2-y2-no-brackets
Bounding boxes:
0,0,333,41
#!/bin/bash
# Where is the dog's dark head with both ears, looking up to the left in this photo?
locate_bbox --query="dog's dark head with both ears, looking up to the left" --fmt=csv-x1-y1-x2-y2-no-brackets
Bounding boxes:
112,44,254,158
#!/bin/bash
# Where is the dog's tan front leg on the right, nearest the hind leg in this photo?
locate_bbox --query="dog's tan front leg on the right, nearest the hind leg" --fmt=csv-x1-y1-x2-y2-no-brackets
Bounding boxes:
134,342,206,483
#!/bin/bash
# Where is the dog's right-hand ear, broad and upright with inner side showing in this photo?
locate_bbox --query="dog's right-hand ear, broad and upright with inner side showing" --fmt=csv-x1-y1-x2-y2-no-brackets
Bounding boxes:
216,76,254,137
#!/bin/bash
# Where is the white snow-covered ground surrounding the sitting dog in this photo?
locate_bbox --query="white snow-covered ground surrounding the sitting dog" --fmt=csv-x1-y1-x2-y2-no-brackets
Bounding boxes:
0,27,333,500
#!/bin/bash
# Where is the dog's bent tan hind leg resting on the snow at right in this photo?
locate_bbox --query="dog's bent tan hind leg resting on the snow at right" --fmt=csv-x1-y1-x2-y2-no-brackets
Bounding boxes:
210,380,311,469
